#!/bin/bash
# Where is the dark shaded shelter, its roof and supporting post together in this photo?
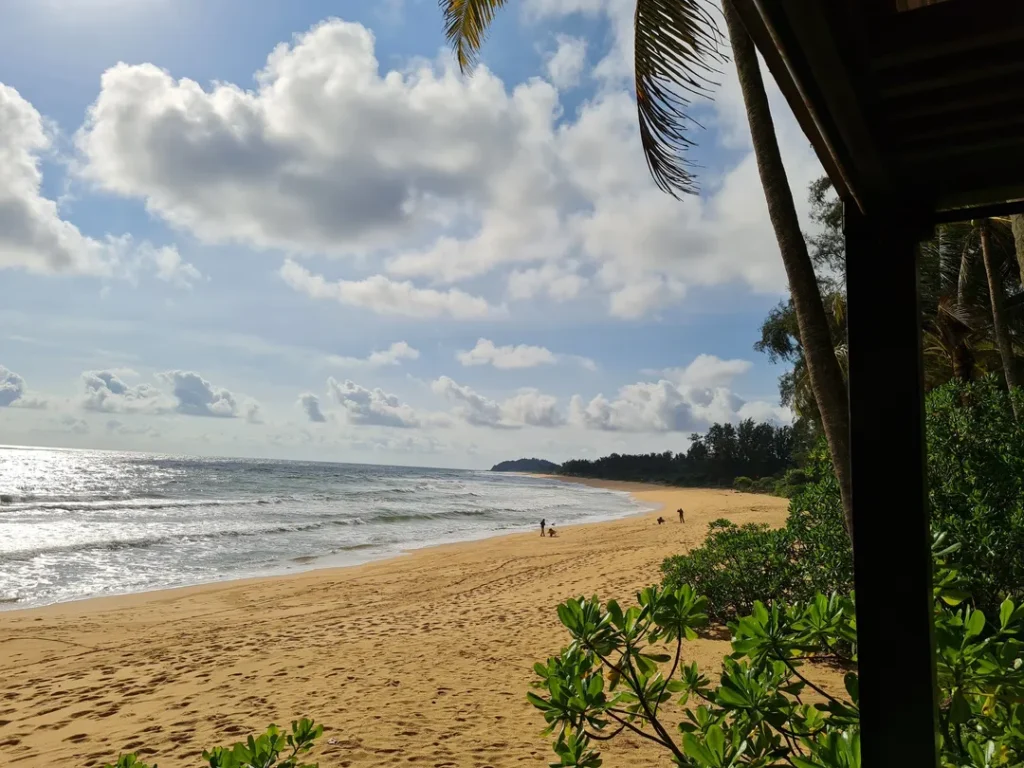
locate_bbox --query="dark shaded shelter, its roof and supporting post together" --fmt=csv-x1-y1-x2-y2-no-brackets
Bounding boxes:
733,0,1024,768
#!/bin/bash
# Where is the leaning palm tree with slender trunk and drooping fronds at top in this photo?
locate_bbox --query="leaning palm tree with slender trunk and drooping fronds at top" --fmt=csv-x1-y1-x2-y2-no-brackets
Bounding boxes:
441,0,853,536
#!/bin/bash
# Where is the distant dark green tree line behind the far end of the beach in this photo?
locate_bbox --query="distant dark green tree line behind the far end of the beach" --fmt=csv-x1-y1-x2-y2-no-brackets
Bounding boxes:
559,419,806,486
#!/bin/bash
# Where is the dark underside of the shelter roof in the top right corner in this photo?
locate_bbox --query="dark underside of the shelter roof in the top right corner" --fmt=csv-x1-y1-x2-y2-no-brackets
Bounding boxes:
736,0,1024,220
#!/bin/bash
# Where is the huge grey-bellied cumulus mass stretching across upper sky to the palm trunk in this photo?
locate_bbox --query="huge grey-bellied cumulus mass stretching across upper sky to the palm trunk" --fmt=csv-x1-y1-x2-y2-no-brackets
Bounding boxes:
70,15,820,318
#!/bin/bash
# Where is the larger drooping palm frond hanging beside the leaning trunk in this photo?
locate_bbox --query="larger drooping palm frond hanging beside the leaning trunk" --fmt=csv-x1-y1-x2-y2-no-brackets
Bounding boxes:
634,0,725,197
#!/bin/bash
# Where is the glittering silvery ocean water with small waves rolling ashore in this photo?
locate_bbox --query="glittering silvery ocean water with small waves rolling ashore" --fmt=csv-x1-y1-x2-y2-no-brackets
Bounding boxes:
0,447,642,609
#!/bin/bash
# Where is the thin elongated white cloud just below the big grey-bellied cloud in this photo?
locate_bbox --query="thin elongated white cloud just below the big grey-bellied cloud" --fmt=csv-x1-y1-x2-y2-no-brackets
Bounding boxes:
281,259,492,319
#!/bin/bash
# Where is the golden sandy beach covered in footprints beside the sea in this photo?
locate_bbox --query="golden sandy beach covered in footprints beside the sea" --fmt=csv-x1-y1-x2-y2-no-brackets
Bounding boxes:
0,482,786,768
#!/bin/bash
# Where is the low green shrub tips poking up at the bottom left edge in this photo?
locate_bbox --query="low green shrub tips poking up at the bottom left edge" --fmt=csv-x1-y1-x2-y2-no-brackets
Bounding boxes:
103,718,324,768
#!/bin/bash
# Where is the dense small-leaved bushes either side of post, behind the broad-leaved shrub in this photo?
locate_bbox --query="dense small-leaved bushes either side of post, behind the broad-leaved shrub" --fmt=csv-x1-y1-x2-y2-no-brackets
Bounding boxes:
662,375,1024,621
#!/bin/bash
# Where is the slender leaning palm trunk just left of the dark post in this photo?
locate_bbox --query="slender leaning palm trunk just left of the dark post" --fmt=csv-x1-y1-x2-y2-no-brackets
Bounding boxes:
723,0,853,538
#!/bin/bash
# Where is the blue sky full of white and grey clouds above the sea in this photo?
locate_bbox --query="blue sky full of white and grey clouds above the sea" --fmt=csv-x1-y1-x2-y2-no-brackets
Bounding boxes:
0,0,821,468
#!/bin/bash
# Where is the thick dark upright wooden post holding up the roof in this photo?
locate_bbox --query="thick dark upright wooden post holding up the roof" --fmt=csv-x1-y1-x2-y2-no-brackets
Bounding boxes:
845,204,938,768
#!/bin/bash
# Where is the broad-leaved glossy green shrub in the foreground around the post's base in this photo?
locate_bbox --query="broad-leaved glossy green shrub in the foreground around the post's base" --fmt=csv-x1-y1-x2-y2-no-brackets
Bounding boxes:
527,538,1024,768
